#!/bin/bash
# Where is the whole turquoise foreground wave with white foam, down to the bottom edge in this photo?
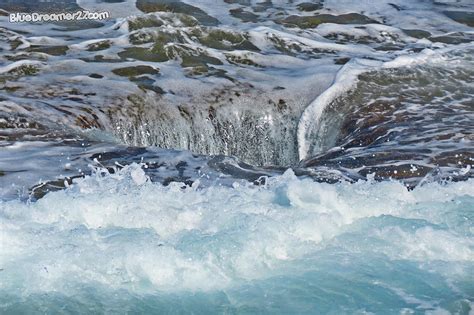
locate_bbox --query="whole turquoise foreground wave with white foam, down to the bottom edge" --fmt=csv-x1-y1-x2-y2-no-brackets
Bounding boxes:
0,165,474,314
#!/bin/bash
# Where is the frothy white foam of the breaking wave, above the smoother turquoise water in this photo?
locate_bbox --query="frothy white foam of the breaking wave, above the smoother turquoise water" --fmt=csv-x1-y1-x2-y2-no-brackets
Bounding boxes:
0,164,474,307
